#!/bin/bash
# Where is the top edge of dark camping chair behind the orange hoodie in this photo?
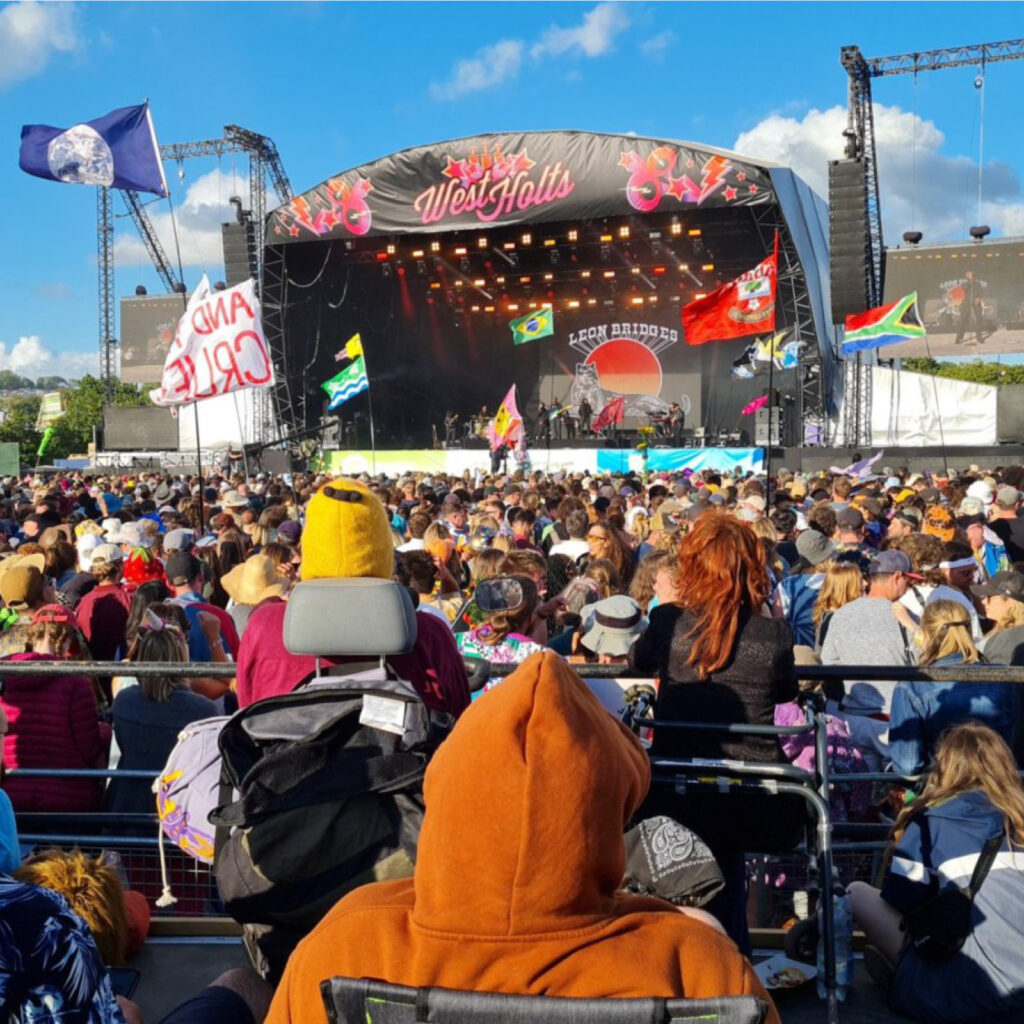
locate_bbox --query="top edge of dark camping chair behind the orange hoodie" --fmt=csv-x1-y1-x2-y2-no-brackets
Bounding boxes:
321,978,768,1024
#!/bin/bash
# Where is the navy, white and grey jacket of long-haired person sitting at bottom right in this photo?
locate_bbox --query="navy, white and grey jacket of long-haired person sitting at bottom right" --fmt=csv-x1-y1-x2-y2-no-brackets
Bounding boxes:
882,791,1024,1024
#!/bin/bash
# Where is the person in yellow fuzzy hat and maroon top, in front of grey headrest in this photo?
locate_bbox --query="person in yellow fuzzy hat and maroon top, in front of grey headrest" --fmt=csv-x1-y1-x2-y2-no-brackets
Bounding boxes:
238,477,469,716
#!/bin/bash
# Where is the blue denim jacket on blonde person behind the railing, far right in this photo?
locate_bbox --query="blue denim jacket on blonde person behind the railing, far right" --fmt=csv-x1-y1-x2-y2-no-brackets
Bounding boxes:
889,654,1019,775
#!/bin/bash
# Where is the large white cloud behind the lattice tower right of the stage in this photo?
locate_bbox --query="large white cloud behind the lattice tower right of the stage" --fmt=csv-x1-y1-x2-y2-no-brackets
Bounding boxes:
733,103,1024,244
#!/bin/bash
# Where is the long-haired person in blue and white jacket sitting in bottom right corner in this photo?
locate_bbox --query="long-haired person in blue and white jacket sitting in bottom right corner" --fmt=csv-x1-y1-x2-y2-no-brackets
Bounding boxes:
850,722,1024,1024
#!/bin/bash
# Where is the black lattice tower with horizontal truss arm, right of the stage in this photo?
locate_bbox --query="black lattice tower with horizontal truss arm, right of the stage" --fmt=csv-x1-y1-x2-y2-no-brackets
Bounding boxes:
830,39,1024,445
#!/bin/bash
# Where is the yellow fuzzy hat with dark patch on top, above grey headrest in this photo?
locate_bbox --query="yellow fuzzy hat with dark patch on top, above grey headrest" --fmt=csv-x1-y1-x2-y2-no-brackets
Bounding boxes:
302,478,394,580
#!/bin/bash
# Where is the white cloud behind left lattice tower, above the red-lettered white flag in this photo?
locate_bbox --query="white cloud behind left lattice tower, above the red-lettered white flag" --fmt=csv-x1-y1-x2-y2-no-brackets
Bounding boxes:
114,170,251,284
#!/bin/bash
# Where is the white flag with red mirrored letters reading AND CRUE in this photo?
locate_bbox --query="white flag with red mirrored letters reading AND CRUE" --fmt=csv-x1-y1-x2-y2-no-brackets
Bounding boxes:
150,274,274,408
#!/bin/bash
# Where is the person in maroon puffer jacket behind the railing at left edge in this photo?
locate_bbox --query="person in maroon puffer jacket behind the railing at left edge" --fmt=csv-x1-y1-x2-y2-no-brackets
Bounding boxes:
0,602,111,811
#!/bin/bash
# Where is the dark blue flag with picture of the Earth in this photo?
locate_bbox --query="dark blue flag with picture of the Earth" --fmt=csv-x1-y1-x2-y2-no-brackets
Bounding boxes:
18,103,168,197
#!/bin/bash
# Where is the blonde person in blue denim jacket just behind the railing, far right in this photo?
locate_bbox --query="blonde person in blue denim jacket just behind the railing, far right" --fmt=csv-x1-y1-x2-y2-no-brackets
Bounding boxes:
889,601,1020,775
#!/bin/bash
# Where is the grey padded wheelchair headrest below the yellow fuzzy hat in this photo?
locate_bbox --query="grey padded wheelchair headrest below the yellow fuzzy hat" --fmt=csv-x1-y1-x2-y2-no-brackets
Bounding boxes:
284,579,416,657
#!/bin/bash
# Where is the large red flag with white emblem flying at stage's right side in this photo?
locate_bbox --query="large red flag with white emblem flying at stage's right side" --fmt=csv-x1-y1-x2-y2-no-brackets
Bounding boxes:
683,236,778,345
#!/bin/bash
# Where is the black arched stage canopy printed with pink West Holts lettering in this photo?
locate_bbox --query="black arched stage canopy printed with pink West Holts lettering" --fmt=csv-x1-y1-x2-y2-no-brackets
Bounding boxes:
266,131,777,245
